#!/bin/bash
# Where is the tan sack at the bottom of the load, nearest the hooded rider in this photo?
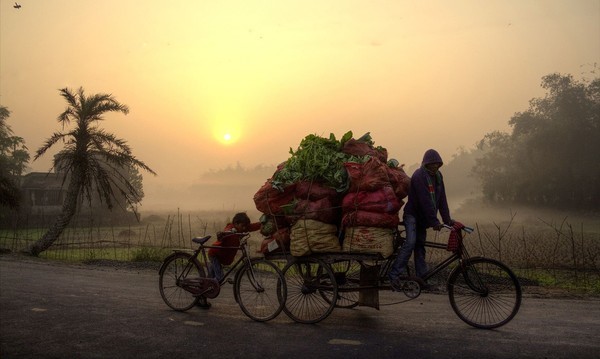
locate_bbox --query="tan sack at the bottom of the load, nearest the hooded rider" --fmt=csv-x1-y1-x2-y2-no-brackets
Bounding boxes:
343,226,394,258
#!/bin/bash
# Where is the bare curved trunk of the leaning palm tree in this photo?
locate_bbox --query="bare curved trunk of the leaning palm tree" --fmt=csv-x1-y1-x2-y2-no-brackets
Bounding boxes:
29,178,81,257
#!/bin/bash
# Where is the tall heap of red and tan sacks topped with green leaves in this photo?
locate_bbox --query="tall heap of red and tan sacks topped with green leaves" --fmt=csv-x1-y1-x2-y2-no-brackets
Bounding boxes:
254,132,410,256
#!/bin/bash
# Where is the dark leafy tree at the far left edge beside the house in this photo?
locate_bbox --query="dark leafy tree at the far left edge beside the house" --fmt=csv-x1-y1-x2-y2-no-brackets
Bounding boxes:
0,106,29,208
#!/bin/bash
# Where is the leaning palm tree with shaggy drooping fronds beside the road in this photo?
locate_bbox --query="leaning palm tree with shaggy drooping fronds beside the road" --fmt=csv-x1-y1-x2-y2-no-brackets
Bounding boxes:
29,87,156,256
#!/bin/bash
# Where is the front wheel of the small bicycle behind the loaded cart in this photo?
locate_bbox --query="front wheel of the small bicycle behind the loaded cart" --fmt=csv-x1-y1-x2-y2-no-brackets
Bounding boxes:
234,259,287,322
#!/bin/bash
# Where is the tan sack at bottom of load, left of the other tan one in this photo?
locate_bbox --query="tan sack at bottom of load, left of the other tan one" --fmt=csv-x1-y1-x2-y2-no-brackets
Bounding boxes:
290,219,341,257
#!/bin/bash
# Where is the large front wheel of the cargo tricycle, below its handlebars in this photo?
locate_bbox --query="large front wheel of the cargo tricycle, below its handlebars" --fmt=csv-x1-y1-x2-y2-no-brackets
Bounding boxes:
448,258,521,329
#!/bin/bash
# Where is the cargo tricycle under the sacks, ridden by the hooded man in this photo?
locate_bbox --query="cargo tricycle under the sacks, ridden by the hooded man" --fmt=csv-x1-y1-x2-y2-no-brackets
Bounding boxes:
276,226,522,329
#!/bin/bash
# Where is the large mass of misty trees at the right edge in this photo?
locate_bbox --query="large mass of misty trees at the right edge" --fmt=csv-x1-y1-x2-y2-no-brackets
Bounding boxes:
474,74,600,210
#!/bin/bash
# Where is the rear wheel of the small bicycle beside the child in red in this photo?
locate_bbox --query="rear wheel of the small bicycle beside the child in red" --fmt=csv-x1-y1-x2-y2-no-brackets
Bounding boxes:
158,253,206,312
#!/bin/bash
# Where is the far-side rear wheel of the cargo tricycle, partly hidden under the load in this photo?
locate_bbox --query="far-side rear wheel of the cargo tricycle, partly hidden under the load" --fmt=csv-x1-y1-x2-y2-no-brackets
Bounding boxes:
320,260,361,308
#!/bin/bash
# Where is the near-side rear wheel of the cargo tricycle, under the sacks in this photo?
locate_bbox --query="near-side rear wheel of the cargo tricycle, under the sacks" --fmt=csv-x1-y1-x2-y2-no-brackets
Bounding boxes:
283,258,338,323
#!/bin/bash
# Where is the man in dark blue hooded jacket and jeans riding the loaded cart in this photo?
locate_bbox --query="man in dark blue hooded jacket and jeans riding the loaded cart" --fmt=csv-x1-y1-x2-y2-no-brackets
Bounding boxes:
389,149,453,288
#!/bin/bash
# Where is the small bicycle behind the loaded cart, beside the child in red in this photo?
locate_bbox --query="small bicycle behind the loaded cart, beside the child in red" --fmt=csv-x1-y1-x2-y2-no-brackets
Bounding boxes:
159,233,287,322
